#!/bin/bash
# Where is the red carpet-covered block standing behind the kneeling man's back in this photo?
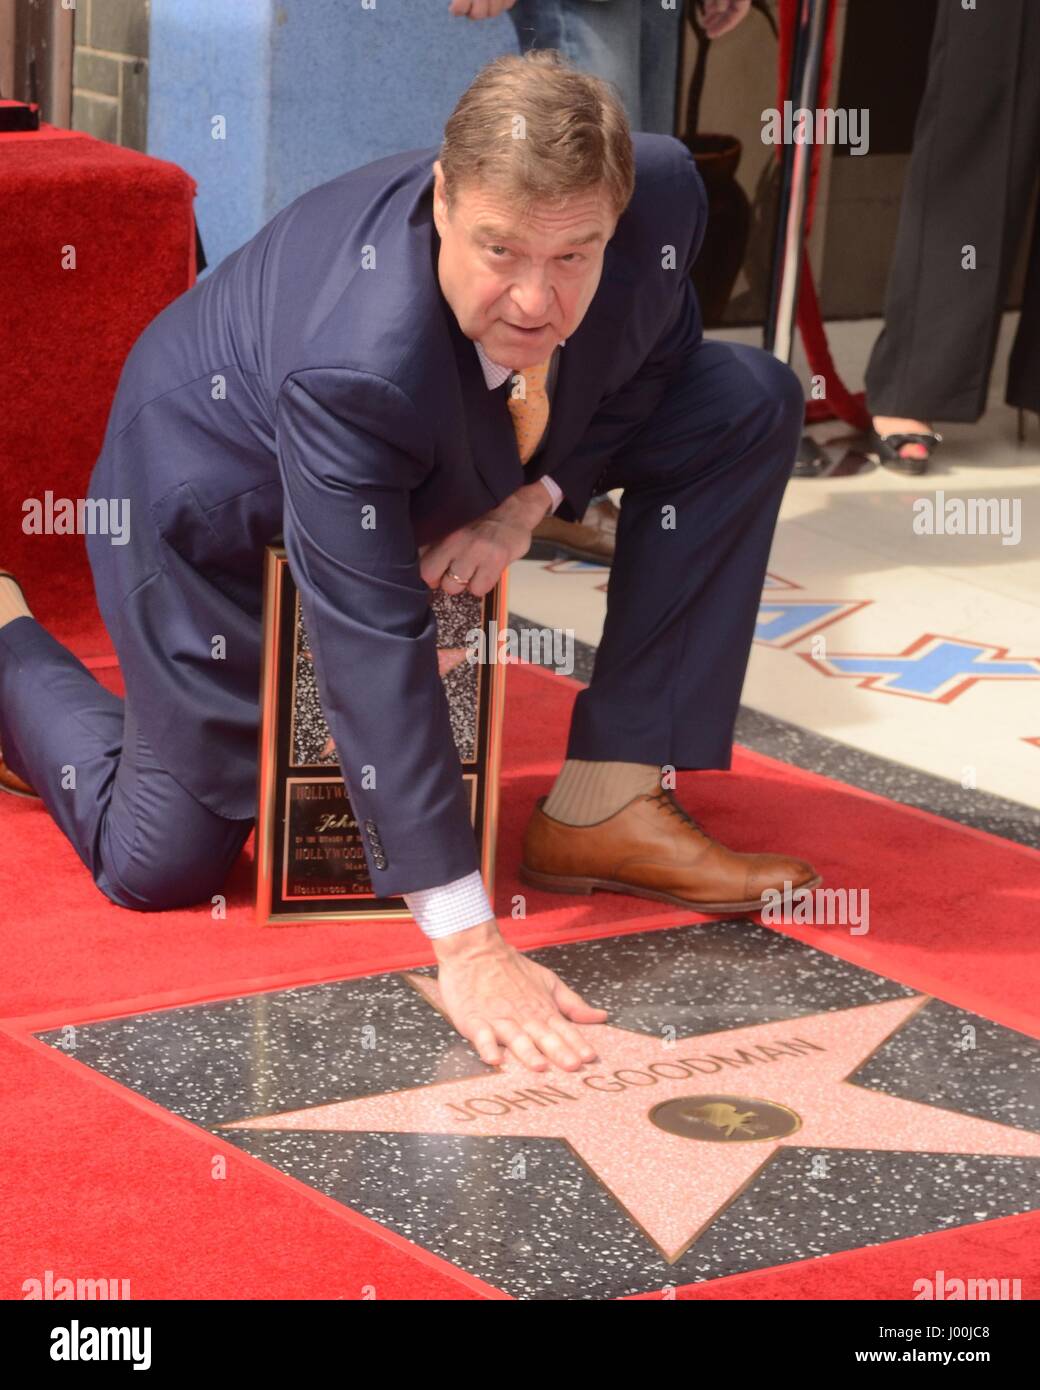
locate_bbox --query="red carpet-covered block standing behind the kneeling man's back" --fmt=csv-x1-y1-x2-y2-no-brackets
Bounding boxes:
0,125,195,638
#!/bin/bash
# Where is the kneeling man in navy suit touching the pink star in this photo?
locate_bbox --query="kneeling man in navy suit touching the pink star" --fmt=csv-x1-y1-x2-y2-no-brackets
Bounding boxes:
0,50,819,1070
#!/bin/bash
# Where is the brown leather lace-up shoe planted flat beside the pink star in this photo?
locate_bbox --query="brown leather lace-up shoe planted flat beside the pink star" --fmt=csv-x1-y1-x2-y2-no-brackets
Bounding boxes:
520,791,822,912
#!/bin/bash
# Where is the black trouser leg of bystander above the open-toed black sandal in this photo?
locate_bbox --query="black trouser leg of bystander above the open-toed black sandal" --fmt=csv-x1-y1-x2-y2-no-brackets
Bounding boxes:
866,0,1040,421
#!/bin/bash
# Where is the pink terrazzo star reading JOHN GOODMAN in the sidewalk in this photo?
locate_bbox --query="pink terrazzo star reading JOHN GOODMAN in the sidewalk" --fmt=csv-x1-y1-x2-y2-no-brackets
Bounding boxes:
221,976,1040,1264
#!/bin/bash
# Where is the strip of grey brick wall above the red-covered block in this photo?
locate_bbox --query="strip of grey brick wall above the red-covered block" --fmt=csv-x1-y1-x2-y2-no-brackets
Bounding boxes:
72,0,149,153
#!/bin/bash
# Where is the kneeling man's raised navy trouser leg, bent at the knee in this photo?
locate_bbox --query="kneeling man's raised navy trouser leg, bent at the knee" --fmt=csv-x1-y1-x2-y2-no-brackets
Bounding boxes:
567,342,805,767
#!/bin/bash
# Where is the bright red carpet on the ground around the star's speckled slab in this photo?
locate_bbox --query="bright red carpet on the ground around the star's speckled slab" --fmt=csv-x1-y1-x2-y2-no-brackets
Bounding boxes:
0,656,1040,1298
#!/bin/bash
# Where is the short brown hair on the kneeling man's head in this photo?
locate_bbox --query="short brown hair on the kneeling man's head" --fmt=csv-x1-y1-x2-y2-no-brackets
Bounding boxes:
439,49,635,217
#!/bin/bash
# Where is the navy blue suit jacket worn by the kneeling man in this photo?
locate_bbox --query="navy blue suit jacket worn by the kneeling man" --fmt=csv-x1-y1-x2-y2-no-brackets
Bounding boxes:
88,127,706,894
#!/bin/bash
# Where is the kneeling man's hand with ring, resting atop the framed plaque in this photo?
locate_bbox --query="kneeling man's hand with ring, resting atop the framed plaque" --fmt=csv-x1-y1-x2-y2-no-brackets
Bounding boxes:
419,482,549,598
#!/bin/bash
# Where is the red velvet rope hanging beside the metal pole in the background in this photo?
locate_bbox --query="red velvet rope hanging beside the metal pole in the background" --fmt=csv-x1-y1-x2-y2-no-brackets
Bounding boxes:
777,0,870,430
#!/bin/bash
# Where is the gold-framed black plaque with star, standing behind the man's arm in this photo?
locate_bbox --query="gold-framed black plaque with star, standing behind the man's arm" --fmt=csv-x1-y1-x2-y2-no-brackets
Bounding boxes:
254,545,506,926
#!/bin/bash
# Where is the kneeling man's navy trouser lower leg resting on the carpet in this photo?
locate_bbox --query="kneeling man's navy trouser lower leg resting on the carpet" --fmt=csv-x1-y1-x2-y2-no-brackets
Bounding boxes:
0,617,252,912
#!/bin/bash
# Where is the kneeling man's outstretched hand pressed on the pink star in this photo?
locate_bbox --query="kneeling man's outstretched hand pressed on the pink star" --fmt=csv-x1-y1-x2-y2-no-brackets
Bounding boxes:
434,919,608,1072
